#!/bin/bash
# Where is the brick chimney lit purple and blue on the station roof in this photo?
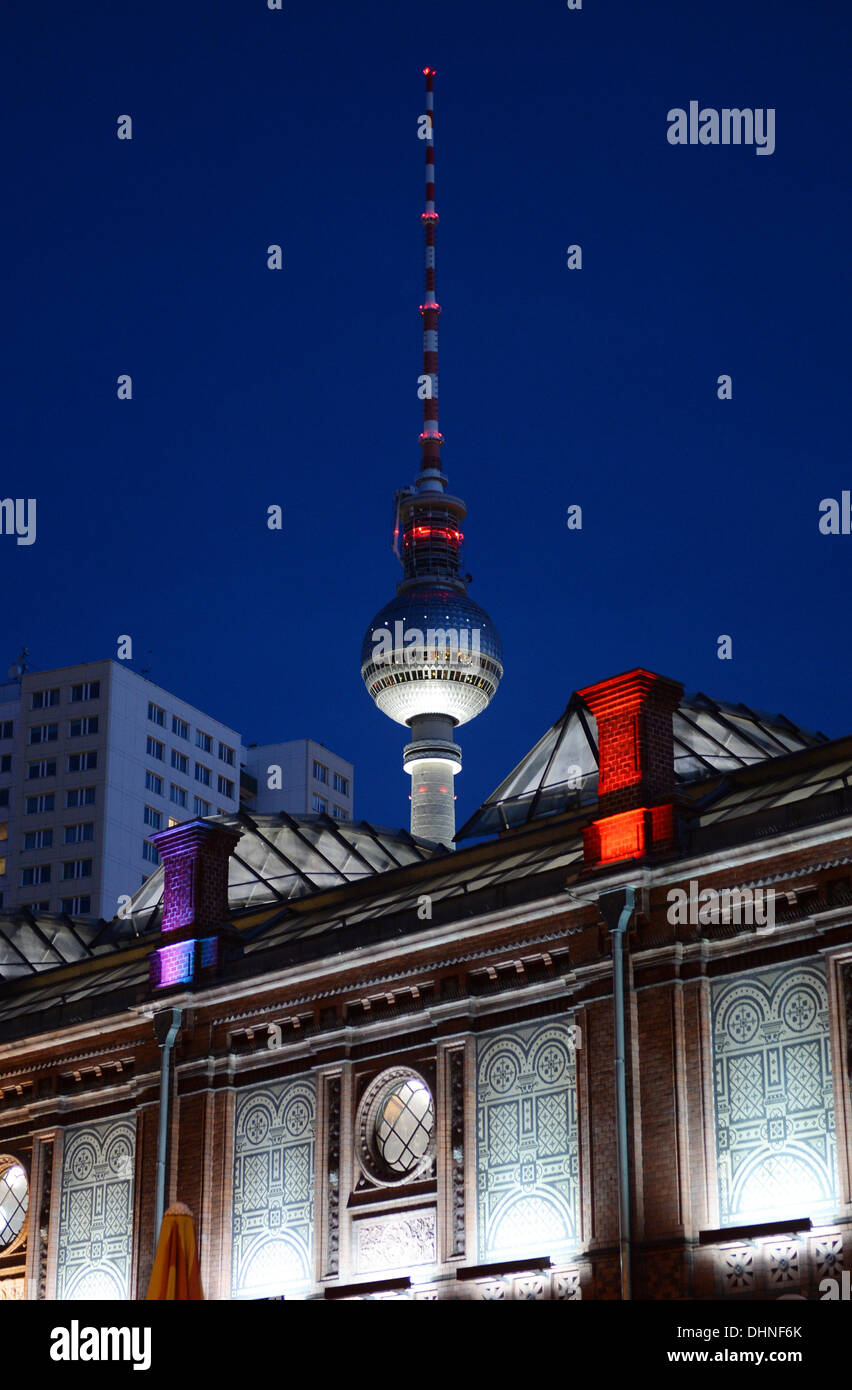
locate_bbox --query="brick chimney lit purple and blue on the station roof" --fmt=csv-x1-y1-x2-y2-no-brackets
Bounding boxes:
150,820,242,990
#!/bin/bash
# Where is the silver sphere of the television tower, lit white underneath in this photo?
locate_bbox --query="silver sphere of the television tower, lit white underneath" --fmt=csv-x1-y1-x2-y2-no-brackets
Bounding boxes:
361,584,503,726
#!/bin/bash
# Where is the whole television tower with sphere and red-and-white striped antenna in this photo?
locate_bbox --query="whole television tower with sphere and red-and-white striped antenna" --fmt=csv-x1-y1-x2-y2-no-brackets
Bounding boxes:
361,68,503,845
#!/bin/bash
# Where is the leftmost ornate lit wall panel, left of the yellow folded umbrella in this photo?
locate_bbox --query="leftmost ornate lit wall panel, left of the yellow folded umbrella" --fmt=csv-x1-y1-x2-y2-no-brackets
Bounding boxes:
56,1118,136,1300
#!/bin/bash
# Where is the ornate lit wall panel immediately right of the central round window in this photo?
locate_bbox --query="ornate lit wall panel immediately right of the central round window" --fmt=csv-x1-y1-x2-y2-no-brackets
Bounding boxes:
477,1019,580,1262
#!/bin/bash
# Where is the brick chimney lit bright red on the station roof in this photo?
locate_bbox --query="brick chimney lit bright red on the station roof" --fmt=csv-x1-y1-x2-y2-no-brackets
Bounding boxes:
577,669,684,867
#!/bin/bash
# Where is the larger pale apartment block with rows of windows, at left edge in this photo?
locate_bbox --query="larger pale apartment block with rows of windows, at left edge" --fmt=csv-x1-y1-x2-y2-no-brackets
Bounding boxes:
0,660,243,920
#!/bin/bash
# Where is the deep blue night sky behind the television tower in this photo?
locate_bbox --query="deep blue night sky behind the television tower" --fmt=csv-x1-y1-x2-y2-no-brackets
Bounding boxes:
0,0,852,826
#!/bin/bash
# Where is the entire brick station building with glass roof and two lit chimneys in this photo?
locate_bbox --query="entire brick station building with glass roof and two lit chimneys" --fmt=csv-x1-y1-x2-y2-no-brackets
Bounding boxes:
0,670,852,1301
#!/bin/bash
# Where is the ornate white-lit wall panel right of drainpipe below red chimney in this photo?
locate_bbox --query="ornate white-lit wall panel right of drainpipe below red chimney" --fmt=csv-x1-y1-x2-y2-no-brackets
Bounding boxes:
713,962,838,1226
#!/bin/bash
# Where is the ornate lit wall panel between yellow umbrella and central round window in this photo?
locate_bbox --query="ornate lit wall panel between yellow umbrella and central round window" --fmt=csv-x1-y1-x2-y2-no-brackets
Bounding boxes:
231,1077,317,1298
